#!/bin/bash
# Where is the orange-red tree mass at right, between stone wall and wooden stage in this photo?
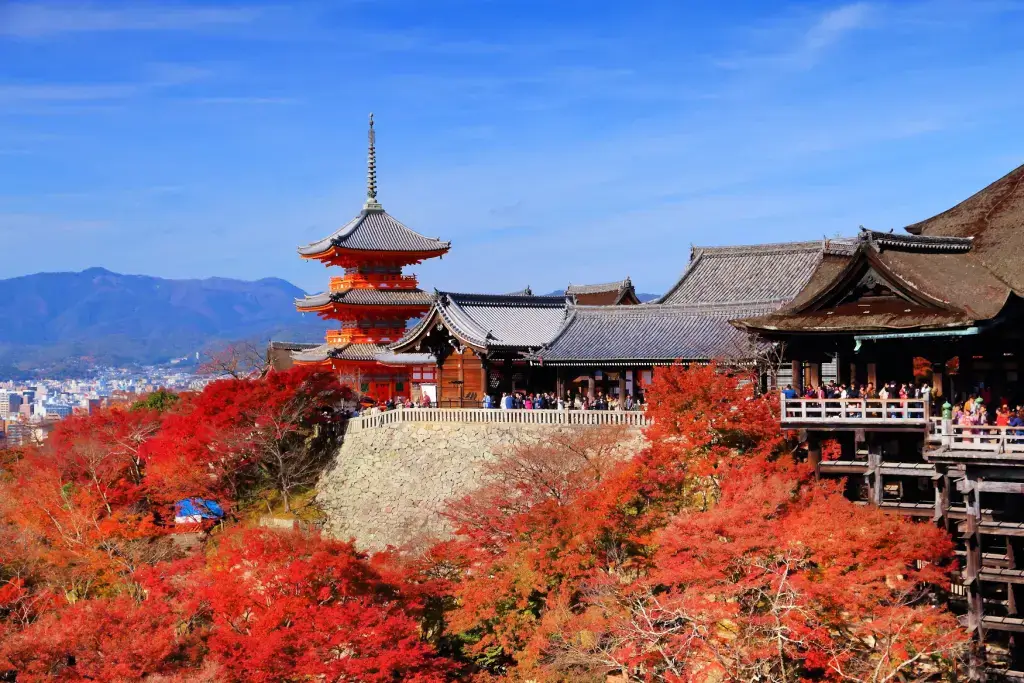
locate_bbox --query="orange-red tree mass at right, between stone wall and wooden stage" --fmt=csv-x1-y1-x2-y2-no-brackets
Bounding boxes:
423,368,966,681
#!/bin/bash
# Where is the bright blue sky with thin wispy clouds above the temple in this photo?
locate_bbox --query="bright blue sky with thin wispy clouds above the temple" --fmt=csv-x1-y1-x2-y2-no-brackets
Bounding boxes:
0,0,1024,292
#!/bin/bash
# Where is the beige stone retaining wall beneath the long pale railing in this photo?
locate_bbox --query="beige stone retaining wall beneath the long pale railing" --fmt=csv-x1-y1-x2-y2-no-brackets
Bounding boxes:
316,423,639,550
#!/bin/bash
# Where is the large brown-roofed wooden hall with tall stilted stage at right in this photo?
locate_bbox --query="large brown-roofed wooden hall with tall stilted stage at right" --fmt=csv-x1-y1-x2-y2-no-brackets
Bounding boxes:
734,167,1024,681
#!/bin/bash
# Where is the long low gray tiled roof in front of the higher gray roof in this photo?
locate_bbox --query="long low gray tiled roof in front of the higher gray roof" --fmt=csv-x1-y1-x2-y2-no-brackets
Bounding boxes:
532,304,774,365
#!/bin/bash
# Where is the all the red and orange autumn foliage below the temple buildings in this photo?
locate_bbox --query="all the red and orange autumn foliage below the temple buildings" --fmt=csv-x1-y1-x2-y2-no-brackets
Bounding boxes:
0,360,966,683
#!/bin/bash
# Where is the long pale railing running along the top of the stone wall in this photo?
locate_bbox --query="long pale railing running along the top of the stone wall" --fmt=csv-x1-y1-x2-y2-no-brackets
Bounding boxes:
348,408,650,430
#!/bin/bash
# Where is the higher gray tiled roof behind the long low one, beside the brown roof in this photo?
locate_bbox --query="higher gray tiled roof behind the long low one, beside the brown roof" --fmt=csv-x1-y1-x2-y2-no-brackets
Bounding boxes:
655,240,852,305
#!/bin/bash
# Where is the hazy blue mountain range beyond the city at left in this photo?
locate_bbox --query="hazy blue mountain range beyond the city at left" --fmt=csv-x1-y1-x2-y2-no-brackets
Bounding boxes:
0,268,327,377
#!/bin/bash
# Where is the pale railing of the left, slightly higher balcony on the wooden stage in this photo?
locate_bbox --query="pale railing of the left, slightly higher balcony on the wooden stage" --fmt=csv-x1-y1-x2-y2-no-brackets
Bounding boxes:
781,396,930,427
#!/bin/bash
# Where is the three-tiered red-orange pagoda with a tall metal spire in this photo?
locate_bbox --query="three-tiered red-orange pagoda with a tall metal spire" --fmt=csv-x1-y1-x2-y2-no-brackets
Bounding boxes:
293,114,451,400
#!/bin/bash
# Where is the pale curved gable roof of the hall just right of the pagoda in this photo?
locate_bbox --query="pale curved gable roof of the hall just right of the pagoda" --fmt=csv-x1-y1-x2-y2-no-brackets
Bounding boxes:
391,292,567,351
